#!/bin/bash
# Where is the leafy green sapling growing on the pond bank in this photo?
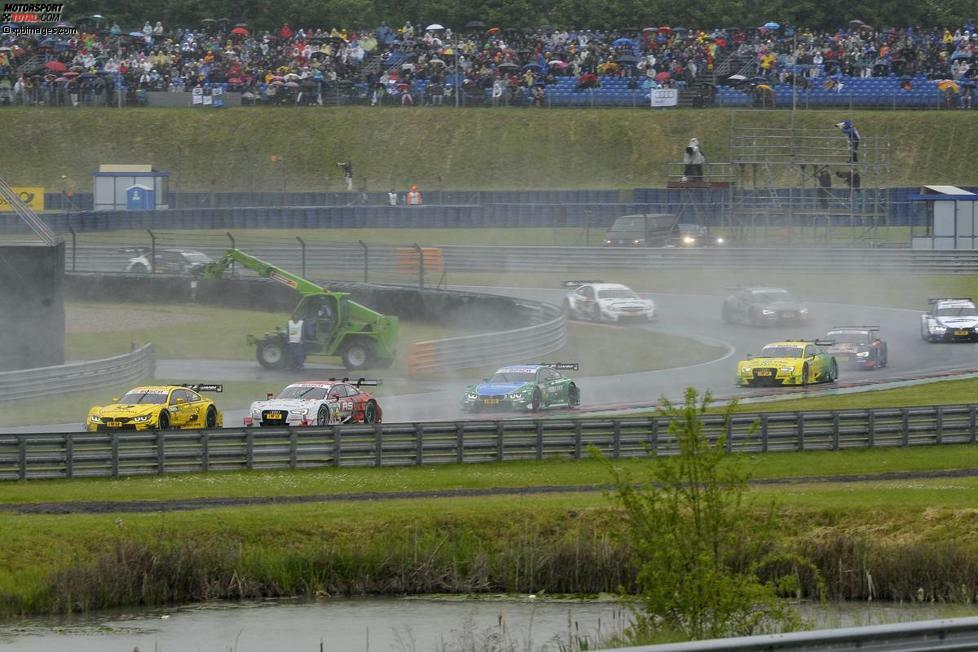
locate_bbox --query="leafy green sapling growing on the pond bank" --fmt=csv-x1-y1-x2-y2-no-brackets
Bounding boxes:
607,388,802,639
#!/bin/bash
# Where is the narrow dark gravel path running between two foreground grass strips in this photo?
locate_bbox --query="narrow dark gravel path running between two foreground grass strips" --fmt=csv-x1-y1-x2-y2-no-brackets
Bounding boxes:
0,469,978,514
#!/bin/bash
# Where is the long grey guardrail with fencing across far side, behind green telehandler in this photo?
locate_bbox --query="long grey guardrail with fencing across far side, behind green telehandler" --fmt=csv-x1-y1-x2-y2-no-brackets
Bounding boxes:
65,241,978,278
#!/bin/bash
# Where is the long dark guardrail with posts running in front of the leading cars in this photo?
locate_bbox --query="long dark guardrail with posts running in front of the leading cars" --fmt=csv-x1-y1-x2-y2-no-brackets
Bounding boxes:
0,405,978,480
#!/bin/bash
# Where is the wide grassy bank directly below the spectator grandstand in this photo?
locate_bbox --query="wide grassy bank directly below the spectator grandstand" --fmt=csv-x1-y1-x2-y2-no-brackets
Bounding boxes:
7,106,978,192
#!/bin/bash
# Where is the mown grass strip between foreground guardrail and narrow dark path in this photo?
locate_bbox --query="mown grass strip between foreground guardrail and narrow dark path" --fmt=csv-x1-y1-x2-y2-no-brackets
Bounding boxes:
0,446,978,504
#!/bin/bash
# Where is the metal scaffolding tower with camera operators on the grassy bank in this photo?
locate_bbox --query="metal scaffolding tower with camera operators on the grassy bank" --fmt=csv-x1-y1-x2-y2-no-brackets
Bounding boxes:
730,113,890,246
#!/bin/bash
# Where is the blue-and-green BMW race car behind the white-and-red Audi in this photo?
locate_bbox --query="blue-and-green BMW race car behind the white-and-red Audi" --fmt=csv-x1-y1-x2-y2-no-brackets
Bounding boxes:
462,363,581,412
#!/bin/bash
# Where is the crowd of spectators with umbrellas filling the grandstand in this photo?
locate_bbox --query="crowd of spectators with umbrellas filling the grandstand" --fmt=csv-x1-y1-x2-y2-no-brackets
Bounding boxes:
0,19,978,106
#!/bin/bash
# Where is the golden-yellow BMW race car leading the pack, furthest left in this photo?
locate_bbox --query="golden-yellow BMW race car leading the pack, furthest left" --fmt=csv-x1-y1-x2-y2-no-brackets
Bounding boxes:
85,385,224,432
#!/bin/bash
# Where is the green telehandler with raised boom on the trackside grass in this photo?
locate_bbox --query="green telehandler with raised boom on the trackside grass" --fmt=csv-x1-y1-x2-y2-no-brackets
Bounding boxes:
202,249,398,370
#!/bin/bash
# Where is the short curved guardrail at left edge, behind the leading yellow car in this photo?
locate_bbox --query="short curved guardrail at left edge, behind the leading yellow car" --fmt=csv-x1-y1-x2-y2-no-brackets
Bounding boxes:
0,344,156,403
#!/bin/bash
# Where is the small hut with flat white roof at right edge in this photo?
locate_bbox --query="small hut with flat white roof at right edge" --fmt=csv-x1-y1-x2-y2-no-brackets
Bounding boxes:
910,186,978,249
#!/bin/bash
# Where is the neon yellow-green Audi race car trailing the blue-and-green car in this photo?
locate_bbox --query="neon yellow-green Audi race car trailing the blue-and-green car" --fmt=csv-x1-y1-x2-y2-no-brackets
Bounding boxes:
737,340,839,387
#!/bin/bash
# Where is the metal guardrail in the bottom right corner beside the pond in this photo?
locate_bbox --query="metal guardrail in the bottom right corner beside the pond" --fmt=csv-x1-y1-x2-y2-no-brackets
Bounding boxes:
607,618,978,652
